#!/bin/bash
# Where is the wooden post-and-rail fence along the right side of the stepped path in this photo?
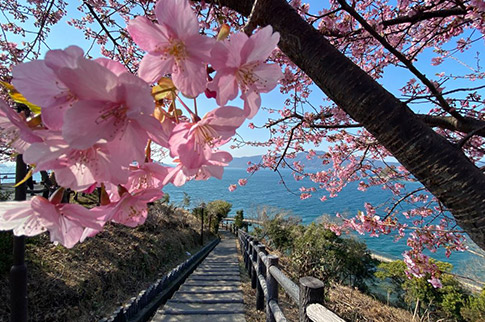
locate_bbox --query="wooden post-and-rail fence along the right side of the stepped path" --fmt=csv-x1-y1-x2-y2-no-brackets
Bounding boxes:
233,229,344,322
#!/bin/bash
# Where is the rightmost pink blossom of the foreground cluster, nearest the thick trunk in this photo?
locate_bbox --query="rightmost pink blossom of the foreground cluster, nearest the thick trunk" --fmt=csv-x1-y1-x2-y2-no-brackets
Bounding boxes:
209,26,283,119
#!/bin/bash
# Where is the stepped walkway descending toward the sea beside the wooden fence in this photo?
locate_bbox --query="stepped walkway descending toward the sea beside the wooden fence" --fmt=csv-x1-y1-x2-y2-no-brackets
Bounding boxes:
152,231,246,322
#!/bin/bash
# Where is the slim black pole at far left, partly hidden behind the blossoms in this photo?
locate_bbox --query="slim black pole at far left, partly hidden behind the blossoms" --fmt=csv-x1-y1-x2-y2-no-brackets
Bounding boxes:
10,154,27,322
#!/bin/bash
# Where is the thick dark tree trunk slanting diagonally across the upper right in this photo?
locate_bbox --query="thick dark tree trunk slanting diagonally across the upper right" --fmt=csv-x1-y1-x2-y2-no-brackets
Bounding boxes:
211,0,485,249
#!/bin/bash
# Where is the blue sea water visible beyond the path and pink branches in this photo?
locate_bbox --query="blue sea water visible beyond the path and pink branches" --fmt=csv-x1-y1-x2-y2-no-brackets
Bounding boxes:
164,168,485,280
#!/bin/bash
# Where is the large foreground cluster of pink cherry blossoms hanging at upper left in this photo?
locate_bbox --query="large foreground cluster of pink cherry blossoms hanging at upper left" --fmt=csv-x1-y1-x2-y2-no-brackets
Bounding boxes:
0,0,283,247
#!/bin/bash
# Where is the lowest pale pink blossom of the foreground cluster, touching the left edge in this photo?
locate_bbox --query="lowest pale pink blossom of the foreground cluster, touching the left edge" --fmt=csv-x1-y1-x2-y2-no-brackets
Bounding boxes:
0,196,103,248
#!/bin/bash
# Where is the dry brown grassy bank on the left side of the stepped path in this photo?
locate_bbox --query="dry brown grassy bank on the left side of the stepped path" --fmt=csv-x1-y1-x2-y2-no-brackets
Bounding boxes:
0,204,212,321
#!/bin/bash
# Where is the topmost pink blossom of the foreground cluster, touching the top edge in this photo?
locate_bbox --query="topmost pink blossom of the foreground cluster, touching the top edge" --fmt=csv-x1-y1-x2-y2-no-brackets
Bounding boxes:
127,0,215,97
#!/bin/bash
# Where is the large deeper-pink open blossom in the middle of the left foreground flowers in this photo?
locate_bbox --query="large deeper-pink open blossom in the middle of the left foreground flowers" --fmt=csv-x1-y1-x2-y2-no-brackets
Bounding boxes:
51,52,167,153
